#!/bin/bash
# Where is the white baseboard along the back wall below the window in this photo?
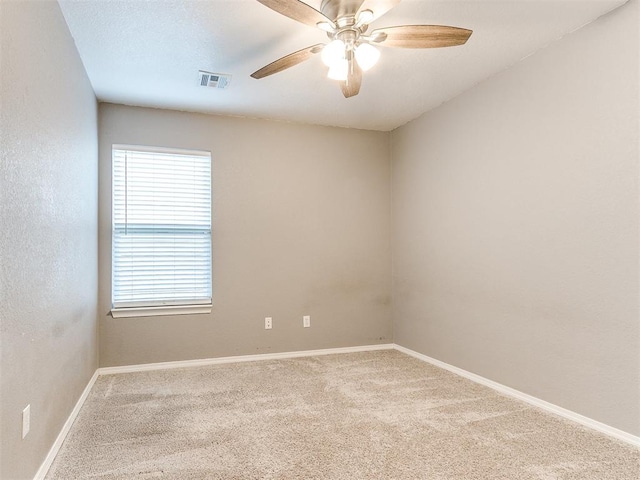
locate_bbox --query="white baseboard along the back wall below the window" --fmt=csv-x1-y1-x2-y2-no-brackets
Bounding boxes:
98,343,394,375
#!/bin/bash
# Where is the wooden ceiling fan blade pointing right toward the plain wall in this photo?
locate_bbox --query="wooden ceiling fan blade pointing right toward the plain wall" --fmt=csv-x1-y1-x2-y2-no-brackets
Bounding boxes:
371,25,473,48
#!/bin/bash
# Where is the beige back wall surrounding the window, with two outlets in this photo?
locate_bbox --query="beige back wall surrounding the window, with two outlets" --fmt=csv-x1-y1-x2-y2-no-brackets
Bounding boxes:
99,104,392,366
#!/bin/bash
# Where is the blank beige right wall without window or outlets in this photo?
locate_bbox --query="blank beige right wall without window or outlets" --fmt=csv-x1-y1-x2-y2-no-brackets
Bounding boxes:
392,0,640,435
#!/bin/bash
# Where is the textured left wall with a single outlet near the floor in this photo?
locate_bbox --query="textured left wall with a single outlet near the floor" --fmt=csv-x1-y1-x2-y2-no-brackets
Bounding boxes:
0,0,98,480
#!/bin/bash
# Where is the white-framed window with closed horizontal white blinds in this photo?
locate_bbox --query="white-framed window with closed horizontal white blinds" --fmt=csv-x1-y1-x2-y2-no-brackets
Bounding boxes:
111,145,211,318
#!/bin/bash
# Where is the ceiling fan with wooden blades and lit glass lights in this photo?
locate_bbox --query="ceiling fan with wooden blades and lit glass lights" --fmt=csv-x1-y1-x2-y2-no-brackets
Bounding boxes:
251,0,472,98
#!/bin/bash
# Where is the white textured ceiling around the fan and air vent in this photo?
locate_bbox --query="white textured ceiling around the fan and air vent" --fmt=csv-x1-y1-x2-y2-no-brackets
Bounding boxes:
59,0,625,130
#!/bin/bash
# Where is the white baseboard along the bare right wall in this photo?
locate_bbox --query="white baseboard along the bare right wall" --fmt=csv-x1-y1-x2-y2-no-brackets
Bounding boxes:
394,344,640,447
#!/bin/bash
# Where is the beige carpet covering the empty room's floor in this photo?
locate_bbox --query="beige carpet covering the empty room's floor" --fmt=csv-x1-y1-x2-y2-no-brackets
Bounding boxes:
47,350,640,480
